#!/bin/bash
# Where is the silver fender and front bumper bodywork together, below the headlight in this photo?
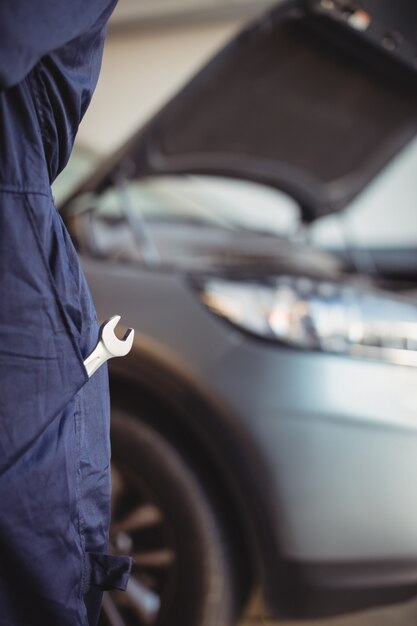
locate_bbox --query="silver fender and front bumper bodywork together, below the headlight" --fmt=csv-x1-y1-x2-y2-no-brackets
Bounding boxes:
84,254,417,616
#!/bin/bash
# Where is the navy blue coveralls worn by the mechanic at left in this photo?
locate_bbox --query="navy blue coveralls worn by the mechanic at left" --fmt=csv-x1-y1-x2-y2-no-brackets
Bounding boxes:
0,0,130,626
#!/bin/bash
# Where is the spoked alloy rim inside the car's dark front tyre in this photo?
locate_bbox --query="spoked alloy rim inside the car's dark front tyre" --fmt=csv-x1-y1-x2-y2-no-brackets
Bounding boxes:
100,461,177,626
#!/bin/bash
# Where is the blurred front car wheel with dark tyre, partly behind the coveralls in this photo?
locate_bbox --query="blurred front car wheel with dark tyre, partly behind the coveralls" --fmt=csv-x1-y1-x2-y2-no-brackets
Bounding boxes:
100,411,237,626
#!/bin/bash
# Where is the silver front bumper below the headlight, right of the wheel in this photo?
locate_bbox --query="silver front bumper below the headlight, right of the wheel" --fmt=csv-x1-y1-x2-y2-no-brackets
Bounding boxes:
209,338,417,615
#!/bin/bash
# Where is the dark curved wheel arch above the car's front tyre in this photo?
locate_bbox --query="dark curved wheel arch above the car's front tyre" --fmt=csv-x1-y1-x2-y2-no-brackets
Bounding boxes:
110,337,288,608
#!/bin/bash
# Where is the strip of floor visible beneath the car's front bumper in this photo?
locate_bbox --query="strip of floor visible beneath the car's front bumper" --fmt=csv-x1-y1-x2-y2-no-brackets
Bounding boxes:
239,599,417,626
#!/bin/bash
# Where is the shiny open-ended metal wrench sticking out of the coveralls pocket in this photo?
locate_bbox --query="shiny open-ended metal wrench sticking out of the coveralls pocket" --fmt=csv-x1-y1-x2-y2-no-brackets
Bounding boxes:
84,315,135,378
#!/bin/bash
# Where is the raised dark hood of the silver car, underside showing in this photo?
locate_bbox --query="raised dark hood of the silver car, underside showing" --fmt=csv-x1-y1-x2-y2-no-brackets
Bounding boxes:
74,0,417,220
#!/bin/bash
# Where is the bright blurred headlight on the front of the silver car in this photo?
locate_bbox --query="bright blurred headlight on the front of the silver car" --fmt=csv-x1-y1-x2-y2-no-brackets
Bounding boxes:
199,276,417,366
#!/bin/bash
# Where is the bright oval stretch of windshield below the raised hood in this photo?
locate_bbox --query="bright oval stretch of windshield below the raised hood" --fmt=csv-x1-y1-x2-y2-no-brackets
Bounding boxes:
89,176,299,235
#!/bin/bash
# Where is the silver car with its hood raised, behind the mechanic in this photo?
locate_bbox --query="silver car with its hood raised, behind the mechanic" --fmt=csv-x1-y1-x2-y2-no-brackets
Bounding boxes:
62,0,417,626
